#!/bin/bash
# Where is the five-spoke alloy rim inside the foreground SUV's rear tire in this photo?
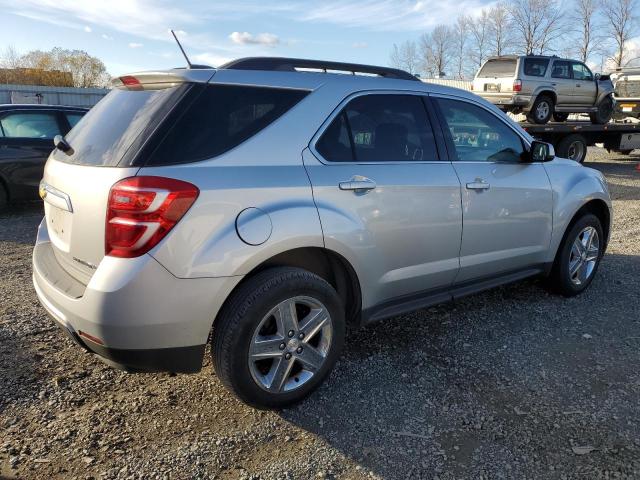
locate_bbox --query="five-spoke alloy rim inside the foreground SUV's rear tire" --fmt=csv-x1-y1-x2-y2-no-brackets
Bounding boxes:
248,296,333,393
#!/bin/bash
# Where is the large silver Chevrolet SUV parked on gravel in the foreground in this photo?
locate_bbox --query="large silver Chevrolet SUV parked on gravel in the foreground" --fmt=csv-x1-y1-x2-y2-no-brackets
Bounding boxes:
33,58,611,407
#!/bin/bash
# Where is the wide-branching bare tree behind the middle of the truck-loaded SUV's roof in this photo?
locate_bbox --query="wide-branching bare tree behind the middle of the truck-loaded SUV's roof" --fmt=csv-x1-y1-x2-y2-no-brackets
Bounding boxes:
510,0,563,54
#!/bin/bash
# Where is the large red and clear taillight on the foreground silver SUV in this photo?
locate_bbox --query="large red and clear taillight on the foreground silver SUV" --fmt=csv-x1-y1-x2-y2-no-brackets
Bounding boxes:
105,177,200,258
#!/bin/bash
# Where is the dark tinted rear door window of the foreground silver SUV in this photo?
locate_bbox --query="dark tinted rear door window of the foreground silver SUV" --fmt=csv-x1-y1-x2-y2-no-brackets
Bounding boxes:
316,95,438,162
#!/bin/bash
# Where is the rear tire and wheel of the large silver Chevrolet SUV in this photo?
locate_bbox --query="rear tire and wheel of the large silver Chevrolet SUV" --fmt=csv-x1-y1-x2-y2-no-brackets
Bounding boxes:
212,267,345,408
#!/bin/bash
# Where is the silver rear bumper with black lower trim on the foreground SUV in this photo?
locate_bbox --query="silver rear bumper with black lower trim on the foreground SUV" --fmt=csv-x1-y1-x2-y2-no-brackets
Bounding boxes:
33,218,240,373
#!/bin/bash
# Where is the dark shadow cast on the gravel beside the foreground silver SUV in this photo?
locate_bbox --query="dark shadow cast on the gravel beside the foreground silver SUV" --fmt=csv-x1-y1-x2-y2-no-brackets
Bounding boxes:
281,254,640,478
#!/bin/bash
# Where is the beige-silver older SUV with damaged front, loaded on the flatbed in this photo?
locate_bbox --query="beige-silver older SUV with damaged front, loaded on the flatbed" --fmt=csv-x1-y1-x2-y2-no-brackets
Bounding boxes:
472,55,614,124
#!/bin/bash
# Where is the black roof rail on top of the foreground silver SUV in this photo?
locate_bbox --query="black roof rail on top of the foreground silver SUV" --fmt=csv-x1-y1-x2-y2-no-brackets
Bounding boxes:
218,57,420,82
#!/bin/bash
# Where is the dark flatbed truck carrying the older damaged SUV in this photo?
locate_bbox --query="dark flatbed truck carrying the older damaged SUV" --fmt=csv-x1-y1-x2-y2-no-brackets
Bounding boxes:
519,121,640,163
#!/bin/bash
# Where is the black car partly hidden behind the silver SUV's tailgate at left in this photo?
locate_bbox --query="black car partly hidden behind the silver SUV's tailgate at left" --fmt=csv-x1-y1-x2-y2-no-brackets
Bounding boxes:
0,105,87,210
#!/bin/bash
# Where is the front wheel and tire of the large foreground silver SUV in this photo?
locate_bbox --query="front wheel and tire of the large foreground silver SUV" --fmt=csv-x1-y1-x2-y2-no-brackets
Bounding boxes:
549,213,605,297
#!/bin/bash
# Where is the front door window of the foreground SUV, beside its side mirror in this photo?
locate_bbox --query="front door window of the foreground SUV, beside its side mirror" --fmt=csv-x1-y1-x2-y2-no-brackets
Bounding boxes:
438,99,524,162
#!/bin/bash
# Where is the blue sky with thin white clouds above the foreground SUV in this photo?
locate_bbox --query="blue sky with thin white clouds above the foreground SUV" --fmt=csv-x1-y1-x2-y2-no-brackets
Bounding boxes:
0,0,492,75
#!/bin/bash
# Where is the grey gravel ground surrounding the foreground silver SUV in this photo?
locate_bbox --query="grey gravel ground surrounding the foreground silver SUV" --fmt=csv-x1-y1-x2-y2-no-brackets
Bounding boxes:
0,149,640,479
